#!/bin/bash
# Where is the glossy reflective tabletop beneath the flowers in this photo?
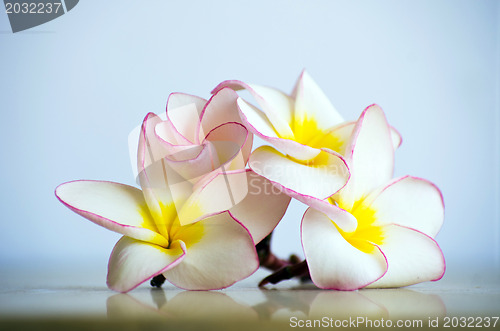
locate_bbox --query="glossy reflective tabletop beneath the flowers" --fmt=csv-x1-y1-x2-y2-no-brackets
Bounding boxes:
0,268,500,329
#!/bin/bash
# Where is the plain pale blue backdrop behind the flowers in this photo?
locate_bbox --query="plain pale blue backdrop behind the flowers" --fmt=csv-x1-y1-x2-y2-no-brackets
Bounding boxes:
0,0,500,282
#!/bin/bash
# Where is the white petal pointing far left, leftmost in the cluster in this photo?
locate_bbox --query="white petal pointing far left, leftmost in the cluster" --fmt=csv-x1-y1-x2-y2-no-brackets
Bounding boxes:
55,180,168,245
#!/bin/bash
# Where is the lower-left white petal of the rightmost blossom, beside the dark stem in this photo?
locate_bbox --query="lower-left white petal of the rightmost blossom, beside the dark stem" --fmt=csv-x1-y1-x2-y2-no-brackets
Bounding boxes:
301,208,387,290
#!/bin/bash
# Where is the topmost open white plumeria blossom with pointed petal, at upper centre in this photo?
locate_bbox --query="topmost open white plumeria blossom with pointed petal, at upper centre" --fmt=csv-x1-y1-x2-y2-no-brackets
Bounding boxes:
212,71,401,209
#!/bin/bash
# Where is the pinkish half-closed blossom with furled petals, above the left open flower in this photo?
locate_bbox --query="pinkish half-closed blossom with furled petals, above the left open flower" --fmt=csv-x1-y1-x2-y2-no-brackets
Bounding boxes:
151,88,253,183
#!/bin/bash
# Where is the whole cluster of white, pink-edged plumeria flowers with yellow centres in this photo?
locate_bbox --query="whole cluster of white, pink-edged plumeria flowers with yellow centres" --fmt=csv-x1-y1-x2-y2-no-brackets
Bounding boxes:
56,72,445,292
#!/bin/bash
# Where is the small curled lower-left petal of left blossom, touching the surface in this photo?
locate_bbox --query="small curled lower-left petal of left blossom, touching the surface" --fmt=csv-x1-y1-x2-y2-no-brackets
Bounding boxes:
107,237,185,292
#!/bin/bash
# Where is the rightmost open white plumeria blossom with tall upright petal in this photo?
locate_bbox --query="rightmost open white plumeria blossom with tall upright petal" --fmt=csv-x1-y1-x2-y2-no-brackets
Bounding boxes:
301,105,445,290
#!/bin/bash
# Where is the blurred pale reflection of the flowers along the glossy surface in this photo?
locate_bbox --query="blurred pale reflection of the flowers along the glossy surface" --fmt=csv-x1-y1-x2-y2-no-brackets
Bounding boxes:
107,288,446,322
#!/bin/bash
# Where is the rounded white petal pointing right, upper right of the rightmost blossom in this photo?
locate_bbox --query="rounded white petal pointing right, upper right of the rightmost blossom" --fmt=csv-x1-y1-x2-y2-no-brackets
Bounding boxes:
371,176,444,237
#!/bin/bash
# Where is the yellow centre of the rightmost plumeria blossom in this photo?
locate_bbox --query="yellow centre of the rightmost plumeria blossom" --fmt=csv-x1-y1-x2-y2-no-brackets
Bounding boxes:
329,198,384,253
